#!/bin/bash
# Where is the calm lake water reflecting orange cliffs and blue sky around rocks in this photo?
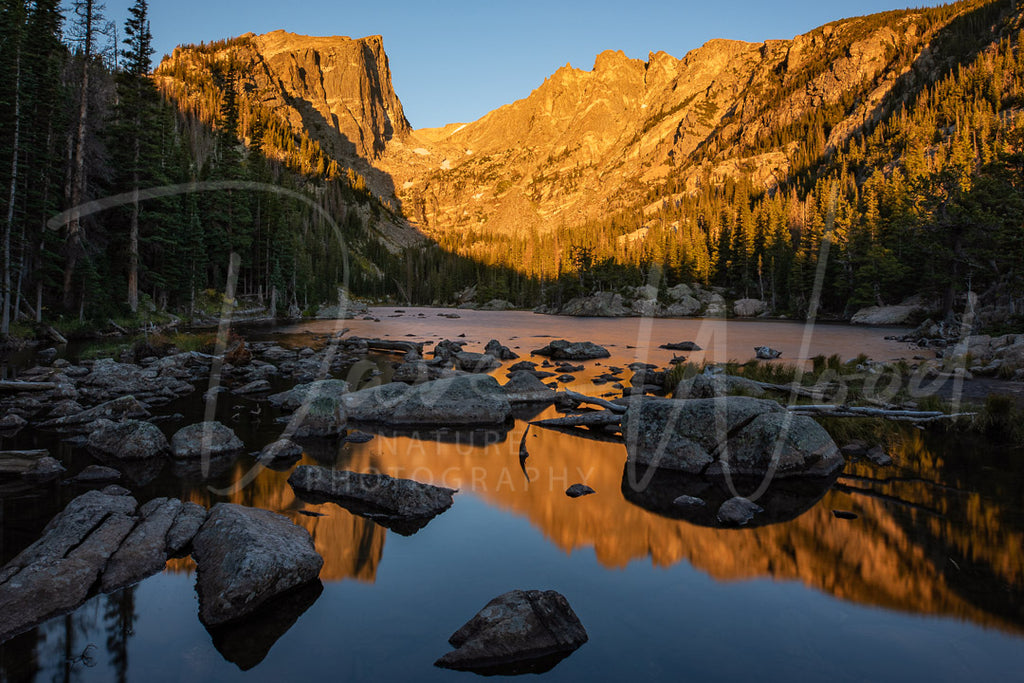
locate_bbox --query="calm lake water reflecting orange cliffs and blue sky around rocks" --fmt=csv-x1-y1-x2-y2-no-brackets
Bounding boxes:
0,308,1024,682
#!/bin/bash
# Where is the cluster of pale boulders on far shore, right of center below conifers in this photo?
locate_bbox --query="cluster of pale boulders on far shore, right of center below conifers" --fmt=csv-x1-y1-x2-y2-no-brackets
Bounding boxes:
535,283,768,317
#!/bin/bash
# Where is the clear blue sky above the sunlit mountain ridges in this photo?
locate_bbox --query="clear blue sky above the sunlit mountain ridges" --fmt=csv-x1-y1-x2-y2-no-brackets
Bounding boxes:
106,0,941,128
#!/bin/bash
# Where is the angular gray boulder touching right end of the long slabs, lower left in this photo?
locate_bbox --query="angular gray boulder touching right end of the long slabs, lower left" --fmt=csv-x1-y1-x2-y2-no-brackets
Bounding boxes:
193,503,324,626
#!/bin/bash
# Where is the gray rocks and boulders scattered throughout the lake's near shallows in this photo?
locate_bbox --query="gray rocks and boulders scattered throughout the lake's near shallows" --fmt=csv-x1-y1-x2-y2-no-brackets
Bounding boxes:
0,323,1016,671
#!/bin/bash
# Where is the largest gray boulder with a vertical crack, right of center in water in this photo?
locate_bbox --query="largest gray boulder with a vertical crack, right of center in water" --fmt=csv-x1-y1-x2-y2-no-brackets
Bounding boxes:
623,396,844,477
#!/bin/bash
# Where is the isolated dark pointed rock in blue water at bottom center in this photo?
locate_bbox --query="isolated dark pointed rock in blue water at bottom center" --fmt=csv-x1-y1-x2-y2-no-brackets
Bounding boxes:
434,591,588,675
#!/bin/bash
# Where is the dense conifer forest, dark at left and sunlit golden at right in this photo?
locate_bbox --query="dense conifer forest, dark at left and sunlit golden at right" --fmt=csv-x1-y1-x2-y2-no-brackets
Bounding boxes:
0,0,1024,334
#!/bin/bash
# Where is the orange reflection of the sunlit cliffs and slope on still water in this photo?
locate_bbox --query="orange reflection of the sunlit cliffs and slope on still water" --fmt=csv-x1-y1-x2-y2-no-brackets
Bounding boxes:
171,411,1024,643
